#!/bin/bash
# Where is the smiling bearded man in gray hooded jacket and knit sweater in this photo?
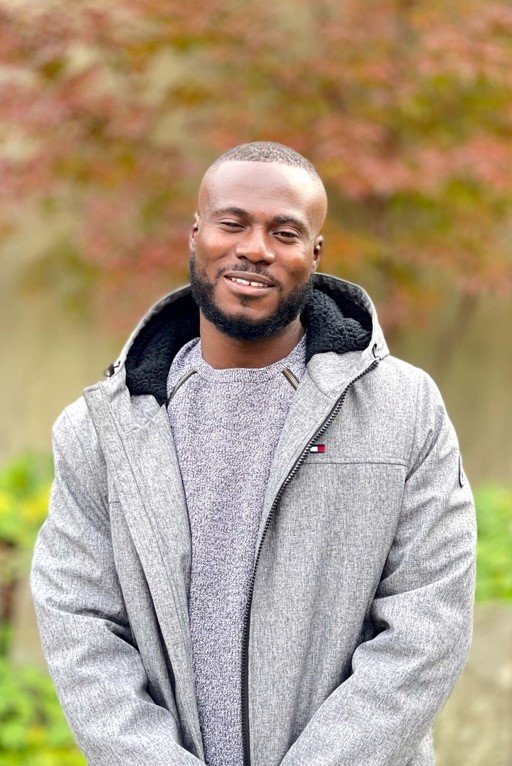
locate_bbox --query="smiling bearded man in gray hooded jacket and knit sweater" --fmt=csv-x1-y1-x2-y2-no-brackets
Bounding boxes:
32,143,474,766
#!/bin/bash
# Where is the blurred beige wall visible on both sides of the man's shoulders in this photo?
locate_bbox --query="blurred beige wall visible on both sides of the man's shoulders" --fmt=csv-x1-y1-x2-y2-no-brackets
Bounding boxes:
0,272,512,483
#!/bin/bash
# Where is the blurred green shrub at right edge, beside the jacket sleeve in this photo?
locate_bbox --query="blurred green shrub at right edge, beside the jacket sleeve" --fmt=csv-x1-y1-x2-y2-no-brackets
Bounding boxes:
475,485,512,601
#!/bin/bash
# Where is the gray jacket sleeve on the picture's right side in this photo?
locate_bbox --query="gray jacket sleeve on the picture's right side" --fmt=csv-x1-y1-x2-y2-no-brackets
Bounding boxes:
281,373,476,766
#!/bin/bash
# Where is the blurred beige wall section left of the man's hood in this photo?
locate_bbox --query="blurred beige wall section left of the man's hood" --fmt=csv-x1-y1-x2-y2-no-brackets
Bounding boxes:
0,288,118,460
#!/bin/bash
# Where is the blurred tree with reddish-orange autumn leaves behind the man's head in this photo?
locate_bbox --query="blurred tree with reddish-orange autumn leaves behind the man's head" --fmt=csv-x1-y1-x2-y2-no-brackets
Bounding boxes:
0,0,512,329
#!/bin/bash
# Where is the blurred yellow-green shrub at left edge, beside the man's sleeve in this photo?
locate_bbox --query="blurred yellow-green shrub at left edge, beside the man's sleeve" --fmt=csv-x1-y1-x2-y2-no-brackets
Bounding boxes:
0,455,86,766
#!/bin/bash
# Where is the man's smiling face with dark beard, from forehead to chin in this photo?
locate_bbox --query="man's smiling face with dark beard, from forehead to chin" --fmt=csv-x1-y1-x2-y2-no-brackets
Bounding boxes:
190,162,326,340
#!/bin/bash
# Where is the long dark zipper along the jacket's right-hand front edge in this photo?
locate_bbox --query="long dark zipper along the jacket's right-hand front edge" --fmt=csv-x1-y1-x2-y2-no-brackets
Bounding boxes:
242,356,380,766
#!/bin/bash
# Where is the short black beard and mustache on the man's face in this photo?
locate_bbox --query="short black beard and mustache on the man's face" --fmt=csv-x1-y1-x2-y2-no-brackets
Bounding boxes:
189,254,314,340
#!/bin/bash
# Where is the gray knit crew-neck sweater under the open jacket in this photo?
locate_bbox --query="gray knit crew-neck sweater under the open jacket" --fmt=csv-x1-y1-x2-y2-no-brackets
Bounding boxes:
168,338,306,766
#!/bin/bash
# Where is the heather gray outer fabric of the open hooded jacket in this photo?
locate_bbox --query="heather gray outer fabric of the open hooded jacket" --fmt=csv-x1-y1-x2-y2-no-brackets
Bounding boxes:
32,276,475,766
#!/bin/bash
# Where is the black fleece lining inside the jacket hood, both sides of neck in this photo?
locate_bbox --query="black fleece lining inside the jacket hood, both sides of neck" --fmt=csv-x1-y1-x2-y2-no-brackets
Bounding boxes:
125,275,372,404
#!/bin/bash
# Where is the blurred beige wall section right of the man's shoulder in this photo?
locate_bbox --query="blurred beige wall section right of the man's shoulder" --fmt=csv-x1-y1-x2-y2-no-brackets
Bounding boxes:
391,296,512,485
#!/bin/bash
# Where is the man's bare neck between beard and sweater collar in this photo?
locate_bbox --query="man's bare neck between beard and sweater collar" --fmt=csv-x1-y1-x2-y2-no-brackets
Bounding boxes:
199,314,304,370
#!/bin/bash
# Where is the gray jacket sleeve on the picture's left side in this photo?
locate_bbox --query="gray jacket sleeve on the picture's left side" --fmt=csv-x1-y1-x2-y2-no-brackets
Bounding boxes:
32,412,201,766
